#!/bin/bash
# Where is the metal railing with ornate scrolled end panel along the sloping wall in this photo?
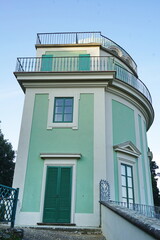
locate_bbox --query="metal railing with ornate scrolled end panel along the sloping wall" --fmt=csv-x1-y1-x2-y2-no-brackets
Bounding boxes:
100,180,160,219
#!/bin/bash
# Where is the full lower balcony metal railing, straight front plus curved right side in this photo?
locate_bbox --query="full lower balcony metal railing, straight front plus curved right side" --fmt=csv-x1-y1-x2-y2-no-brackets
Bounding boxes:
16,56,152,103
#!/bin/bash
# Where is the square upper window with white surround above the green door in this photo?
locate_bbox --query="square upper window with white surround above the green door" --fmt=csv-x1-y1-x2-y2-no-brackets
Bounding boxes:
47,91,80,129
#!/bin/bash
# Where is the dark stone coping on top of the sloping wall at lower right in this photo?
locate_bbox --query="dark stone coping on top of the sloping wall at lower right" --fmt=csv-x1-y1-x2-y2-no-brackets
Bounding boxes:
100,201,160,239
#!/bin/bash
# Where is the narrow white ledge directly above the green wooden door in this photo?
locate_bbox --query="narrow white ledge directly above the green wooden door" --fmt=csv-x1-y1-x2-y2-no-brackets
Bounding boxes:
40,153,82,160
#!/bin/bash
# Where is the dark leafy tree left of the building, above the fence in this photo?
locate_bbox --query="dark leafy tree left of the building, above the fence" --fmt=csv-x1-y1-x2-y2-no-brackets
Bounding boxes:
0,130,15,187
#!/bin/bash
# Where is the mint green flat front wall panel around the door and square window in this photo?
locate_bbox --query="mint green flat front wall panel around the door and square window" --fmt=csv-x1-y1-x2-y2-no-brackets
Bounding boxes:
22,94,94,213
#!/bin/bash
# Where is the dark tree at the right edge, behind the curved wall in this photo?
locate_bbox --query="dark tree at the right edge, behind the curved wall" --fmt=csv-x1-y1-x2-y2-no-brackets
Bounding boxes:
149,149,160,206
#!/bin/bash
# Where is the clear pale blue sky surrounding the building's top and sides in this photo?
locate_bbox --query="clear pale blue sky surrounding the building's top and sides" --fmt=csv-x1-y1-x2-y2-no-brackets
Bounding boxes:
0,0,160,178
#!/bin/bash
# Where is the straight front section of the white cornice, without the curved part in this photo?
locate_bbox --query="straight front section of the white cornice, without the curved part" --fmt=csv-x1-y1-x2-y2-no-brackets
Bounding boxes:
15,71,115,91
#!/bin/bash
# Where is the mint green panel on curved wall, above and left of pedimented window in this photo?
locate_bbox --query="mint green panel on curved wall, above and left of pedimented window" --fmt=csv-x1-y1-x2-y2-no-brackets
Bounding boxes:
112,100,136,201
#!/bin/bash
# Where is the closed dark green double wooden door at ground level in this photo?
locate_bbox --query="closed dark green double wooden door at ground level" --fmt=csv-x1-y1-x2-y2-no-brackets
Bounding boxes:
43,167,72,223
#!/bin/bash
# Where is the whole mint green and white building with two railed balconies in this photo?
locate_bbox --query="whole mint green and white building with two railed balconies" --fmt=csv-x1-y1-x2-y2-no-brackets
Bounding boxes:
13,32,154,227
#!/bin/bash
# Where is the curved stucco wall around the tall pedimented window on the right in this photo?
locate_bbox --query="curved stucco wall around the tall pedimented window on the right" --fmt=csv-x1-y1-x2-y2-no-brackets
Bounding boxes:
109,94,153,205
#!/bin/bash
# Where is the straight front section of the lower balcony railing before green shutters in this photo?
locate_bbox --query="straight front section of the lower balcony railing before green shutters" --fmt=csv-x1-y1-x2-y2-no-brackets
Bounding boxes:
16,56,114,72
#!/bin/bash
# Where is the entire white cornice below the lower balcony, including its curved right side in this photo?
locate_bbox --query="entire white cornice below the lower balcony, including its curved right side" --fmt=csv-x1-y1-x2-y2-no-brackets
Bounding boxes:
14,71,154,130
